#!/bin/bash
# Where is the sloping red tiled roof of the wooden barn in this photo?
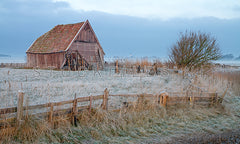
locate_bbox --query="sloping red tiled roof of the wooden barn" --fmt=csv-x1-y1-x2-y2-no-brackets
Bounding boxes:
27,22,84,53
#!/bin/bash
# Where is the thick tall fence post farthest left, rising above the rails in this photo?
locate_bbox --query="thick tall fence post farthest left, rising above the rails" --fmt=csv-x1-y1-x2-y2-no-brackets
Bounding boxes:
17,91,24,125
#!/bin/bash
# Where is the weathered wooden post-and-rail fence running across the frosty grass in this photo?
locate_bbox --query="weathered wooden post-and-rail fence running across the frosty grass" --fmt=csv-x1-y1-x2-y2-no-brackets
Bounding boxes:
0,89,223,128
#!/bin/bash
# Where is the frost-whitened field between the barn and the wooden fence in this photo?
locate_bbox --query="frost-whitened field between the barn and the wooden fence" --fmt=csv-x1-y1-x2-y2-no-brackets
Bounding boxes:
0,68,229,108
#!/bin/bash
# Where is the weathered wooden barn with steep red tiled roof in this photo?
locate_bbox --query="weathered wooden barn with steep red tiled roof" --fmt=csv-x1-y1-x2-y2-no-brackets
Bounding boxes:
26,20,105,70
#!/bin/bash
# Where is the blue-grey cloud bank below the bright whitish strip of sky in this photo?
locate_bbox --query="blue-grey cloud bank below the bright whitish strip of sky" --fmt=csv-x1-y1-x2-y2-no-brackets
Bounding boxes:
0,0,240,56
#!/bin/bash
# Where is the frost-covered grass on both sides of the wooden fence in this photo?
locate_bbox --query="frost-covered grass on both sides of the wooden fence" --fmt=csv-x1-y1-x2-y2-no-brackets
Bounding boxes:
0,68,240,143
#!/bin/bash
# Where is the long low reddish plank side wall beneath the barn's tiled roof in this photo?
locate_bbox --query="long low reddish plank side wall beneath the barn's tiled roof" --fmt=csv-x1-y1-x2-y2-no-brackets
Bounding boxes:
27,52,65,69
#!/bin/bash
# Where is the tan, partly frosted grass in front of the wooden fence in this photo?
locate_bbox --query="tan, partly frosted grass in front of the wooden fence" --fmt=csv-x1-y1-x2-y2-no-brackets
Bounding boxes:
0,94,240,143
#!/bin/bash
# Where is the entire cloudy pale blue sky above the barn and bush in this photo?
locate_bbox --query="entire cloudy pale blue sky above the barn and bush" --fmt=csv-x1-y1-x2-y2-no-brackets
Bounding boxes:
0,0,240,57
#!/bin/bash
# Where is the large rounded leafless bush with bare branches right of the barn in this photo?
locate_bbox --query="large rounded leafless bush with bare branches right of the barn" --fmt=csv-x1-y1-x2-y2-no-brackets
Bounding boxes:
169,31,221,71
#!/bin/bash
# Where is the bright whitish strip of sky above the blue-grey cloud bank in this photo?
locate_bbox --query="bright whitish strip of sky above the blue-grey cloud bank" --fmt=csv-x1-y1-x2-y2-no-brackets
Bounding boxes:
53,0,240,20
